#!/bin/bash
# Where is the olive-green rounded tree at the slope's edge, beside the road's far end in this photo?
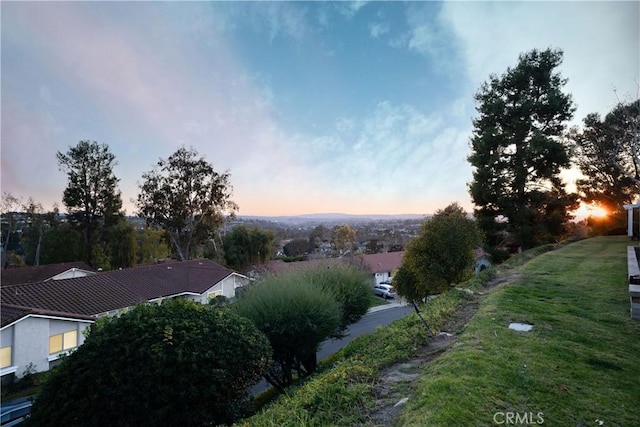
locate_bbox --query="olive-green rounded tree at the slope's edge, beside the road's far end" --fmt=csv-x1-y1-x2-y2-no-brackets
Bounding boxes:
393,203,481,301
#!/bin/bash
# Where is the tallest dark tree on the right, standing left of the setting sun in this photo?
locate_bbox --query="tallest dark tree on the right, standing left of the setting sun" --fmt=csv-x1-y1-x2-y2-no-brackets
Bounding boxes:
468,49,578,254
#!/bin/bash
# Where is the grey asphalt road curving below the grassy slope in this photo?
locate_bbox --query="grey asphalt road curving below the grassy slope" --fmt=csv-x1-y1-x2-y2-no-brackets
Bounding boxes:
251,305,414,395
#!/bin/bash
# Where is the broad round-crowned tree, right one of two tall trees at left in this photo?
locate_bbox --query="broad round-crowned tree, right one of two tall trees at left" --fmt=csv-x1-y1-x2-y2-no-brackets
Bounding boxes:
136,147,238,260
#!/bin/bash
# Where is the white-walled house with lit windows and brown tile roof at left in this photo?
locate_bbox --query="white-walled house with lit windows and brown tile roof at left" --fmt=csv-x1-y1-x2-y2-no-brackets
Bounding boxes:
0,260,249,378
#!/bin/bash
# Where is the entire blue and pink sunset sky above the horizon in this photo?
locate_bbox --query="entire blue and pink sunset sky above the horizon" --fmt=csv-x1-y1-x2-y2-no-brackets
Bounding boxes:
0,1,640,216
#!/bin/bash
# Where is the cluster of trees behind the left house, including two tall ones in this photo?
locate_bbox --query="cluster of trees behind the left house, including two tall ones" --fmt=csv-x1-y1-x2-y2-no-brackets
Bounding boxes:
2,141,232,270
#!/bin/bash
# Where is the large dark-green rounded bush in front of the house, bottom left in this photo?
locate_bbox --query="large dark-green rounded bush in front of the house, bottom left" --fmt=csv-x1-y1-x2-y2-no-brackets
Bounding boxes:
29,300,270,427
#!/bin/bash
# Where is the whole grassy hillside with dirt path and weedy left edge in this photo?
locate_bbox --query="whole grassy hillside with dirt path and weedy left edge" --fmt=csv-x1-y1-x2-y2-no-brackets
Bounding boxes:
240,237,640,426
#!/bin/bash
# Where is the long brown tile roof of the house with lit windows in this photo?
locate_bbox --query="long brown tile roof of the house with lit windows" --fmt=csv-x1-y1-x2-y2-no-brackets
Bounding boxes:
0,260,233,323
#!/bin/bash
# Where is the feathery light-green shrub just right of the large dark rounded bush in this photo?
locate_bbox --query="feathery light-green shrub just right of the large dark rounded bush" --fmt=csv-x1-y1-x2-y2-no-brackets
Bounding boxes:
232,273,341,391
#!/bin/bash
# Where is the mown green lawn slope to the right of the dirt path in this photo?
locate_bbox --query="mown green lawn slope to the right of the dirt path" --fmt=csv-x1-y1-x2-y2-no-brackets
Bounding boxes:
396,237,640,426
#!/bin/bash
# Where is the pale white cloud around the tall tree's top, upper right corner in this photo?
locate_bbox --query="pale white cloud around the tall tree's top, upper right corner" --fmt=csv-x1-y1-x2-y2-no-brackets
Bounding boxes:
441,2,640,121
